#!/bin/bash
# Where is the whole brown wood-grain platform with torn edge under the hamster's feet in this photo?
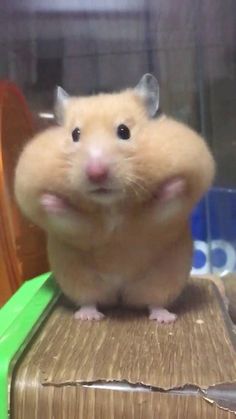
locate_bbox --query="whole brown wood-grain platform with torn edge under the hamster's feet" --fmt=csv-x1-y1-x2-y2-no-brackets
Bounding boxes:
11,279,236,419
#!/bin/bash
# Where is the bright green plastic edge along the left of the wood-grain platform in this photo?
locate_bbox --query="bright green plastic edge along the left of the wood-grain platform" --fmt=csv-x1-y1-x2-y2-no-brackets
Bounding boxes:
0,274,59,419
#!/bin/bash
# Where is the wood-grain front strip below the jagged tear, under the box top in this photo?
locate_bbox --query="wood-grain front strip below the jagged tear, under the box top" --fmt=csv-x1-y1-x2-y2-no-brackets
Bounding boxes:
10,386,235,419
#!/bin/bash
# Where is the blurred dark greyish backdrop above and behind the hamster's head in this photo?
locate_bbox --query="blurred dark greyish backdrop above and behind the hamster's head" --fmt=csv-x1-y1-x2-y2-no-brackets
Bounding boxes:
0,0,236,187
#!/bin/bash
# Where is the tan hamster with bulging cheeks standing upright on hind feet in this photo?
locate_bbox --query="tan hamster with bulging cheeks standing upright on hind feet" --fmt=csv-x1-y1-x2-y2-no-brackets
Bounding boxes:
15,74,215,323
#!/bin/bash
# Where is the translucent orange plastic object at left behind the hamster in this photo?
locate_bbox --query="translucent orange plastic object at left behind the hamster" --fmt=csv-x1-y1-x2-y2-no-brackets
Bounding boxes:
0,81,48,305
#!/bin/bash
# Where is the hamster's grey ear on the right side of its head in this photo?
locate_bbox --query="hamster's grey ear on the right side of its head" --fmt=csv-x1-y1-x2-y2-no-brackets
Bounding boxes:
134,73,160,118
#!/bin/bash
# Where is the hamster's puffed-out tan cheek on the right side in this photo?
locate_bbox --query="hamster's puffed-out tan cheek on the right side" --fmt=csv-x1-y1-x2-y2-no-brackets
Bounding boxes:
133,118,215,210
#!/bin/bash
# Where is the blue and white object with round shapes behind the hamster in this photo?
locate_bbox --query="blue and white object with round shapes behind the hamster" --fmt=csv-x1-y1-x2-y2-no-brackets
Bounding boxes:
191,188,236,275
